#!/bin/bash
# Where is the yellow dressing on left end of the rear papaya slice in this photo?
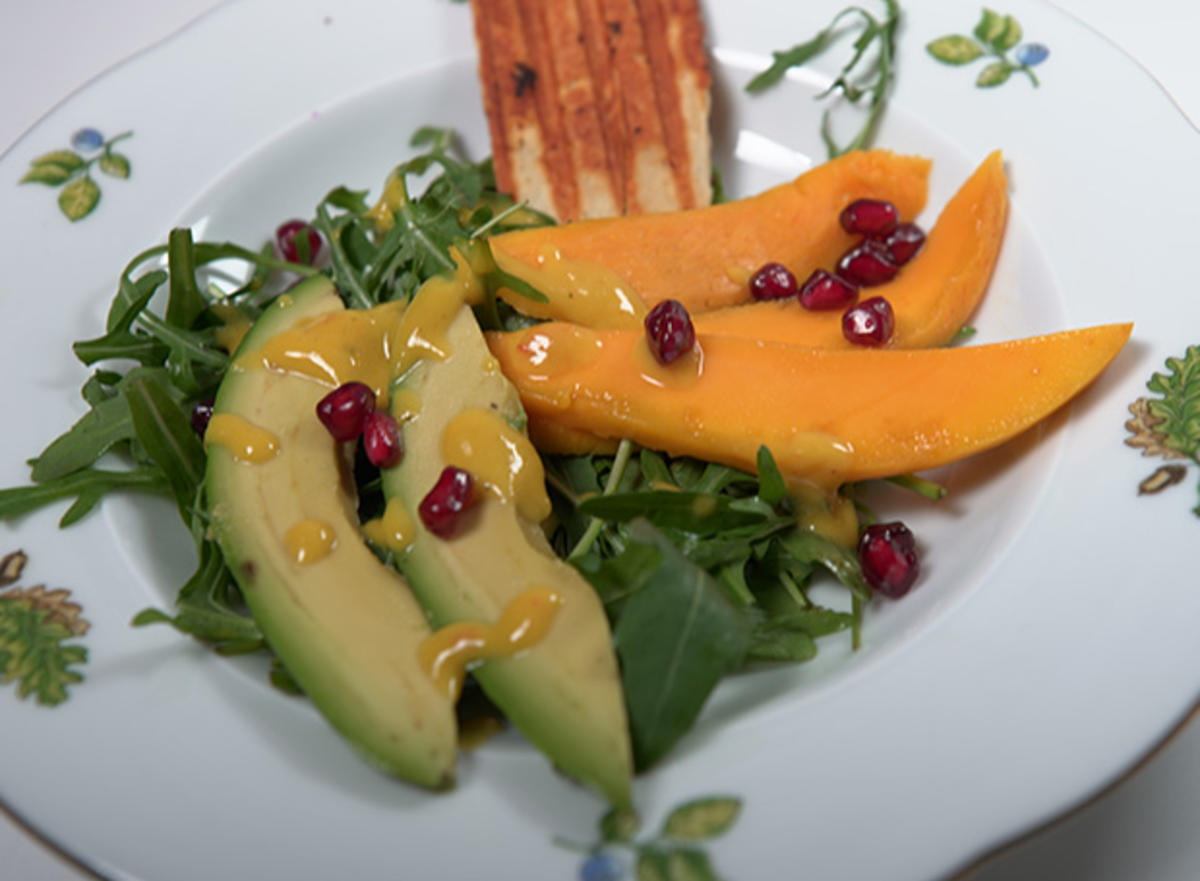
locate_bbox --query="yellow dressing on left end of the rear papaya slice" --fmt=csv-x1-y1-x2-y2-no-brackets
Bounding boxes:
492,245,647,328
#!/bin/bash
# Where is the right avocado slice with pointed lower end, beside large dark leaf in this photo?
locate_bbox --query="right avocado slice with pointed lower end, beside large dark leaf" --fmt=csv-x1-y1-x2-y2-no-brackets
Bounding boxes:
383,302,632,807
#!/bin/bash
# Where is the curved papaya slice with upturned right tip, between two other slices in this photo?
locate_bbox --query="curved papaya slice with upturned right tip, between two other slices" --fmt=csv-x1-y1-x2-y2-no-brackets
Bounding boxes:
695,150,1008,349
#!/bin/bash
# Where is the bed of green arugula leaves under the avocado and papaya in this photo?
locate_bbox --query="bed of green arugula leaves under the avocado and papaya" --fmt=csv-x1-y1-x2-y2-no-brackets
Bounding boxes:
0,128,883,768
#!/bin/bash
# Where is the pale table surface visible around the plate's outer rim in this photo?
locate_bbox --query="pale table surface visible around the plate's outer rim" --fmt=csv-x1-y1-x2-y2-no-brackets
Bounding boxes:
0,0,1200,881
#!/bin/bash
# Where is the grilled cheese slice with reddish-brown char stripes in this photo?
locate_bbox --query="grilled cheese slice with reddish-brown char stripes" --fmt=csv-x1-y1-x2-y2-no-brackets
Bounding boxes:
472,0,712,221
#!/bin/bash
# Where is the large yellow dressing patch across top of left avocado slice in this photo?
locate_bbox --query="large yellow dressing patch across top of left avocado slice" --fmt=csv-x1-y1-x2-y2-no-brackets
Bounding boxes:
238,302,404,407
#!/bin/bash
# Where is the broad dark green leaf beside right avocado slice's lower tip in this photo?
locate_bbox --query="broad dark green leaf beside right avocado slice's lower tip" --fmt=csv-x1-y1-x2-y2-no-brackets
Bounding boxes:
613,521,756,769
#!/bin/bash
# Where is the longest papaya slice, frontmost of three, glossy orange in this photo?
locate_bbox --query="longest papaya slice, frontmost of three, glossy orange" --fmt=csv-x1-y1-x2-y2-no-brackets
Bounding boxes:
488,323,1133,490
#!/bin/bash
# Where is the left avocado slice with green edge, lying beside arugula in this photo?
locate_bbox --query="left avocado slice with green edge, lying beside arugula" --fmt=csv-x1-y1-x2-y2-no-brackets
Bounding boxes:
206,277,457,787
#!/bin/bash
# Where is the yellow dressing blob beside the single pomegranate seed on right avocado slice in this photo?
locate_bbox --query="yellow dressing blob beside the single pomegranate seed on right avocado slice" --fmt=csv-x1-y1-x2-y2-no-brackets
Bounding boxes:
442,409,550,523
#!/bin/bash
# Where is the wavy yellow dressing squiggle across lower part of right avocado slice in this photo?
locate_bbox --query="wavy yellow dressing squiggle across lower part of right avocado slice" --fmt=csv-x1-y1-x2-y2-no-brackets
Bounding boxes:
416,587,563,700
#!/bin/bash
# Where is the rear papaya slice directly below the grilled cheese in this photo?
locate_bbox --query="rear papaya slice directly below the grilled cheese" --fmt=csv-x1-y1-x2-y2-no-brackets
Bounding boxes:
490,150,930,326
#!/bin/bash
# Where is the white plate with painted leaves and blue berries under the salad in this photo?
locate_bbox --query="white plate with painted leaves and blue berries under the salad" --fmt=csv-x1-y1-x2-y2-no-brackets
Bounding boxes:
0,0,1200,879
